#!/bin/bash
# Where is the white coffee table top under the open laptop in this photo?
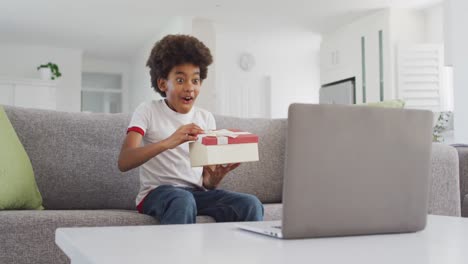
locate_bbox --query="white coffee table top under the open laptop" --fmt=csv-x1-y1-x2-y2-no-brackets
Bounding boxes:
55,216,468,264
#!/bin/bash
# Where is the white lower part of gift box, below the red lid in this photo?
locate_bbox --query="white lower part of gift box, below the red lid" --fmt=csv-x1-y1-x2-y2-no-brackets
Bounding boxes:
189,142,259,167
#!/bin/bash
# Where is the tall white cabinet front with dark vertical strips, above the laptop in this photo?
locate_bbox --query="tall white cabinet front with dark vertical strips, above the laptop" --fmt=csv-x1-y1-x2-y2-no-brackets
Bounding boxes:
321,10,394,103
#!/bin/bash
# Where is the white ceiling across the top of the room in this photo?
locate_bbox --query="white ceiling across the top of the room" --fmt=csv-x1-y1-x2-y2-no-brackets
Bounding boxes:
0,0,442,60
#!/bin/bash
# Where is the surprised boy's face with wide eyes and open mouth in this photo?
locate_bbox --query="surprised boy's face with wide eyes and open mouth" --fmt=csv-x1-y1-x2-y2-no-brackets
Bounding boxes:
158,63,202,114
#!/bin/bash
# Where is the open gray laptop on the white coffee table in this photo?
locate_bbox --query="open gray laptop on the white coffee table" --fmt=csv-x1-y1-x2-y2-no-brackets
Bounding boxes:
238,104,432,239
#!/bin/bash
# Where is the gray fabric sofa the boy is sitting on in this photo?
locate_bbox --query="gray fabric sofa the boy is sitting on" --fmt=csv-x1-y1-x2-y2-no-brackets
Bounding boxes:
0,107,460,264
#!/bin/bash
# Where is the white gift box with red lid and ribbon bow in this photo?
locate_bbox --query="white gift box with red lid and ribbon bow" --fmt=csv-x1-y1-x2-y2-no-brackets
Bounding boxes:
189,129,258,167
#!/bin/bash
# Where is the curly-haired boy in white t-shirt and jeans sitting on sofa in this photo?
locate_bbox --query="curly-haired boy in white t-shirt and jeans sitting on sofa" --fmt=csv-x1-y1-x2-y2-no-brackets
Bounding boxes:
118,35,263,224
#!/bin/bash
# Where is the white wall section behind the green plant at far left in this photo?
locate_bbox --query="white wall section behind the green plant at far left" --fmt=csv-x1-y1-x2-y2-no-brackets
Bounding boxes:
0,44,82,112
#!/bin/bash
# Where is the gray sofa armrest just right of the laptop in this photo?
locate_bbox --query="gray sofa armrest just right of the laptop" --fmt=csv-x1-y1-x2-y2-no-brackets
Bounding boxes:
428,143,461,216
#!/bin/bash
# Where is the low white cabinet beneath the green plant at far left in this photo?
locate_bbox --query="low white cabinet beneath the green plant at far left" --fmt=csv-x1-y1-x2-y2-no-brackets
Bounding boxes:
0,78,57,110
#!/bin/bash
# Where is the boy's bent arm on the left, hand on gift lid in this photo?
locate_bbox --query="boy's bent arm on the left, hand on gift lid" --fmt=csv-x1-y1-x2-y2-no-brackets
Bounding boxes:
118,123,204,172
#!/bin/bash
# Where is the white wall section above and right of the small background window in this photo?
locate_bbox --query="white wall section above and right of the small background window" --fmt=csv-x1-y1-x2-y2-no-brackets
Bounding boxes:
82,56,131,113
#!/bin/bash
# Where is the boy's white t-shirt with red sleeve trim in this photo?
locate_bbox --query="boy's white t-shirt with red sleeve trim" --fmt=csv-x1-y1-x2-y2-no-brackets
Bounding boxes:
127,99,216,205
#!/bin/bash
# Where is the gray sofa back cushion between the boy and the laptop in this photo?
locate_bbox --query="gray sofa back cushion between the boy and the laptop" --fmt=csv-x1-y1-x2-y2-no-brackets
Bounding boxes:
215,115,287,203
